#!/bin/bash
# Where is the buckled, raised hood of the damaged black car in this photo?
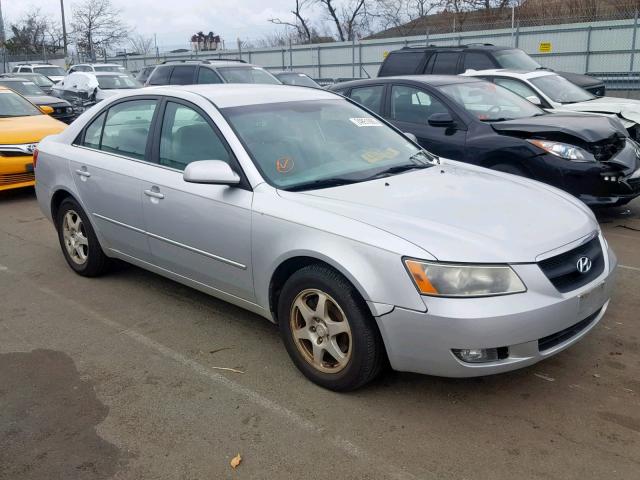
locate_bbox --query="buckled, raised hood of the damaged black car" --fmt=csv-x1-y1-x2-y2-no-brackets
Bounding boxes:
490,113,622,143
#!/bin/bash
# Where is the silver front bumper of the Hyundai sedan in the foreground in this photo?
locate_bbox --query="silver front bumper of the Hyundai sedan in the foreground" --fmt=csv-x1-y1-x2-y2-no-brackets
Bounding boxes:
376,240,617,377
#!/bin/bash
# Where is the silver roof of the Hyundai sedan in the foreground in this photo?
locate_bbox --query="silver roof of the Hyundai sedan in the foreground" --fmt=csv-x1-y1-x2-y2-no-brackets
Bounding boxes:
143,83,342,108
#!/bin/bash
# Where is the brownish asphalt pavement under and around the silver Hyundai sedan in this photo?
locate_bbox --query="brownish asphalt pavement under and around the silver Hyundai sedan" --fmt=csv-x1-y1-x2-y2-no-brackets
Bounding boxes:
0,189,640,480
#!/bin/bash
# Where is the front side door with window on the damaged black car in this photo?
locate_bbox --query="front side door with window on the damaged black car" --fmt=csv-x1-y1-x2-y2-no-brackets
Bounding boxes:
388,84,467,160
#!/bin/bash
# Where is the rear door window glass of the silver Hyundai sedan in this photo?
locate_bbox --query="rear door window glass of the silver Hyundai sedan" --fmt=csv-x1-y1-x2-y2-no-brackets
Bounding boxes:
100,100,158,160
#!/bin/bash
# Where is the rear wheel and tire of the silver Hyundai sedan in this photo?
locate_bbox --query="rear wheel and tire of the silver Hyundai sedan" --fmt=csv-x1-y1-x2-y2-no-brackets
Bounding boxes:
56,198,110,277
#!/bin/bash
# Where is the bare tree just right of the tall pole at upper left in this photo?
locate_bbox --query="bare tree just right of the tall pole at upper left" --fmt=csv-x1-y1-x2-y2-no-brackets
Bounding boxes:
71,0,129,59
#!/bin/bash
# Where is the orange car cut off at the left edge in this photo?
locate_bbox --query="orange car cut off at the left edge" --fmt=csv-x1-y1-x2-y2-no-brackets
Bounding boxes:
0,87,66,191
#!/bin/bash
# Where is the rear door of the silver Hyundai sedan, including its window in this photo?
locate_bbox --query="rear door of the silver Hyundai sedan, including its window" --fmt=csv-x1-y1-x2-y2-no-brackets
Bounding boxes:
70,96,159,262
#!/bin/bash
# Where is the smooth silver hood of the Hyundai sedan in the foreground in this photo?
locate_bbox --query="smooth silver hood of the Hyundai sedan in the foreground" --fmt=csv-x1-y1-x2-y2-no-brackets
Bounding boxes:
279,162,597,263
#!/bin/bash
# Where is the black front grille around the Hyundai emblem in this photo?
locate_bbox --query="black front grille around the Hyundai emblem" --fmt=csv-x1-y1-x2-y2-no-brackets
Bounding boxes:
538,237,604,293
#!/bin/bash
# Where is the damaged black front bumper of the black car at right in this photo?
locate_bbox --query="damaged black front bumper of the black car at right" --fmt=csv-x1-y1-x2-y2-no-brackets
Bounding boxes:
536,141,640,207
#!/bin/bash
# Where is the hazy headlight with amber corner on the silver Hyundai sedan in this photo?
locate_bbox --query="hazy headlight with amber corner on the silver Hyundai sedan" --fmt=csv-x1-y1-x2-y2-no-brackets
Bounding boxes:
404,259,527,297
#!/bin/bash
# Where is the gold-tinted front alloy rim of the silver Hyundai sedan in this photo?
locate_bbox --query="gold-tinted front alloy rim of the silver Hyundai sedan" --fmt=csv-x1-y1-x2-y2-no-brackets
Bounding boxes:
289,288,353,373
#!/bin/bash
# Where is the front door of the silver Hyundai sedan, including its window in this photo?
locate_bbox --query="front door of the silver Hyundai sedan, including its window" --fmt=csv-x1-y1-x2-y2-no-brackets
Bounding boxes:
142,100,254,301
